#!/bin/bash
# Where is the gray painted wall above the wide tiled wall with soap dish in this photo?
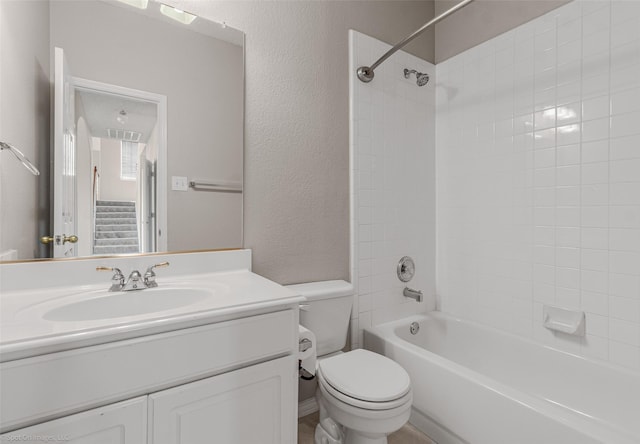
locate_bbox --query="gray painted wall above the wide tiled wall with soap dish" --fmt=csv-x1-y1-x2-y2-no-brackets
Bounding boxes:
435,0,570,63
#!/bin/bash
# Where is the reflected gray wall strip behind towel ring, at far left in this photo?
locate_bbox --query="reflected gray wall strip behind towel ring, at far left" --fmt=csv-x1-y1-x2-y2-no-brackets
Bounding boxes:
0,0,51,259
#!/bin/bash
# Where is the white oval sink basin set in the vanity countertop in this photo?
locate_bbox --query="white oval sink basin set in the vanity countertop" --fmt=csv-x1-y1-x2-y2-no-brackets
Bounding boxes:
43,288,213,321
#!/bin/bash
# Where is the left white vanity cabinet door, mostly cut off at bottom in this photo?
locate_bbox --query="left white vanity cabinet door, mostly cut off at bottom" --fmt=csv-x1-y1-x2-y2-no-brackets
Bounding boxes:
0,396,147,444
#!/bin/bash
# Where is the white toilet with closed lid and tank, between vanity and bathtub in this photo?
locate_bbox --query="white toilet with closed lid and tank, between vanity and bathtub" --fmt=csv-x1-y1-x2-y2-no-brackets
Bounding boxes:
289,281,412,444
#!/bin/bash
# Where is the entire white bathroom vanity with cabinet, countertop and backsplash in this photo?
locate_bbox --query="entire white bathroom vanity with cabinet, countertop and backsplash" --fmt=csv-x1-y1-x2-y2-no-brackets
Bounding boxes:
0,250,302,444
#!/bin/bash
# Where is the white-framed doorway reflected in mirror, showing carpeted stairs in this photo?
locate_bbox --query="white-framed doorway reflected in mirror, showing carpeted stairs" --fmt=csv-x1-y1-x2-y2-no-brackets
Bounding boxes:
73,78,166,256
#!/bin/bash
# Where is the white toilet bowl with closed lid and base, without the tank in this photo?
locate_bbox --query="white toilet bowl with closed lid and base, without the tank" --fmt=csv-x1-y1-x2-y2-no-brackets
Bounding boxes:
315,350,412,444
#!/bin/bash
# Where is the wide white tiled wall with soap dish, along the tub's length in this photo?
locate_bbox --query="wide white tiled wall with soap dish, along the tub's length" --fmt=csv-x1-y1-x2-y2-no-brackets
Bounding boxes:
436,0,640,370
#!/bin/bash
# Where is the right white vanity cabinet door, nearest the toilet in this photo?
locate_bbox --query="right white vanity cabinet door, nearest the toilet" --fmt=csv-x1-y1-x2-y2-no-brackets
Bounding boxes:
149,356,297,444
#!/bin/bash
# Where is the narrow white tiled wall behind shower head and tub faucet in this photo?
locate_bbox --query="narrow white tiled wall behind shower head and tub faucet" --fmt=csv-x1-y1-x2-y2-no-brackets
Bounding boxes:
349,31,436,348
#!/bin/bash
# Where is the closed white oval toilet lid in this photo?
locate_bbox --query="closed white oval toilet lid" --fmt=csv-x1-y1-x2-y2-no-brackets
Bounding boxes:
319,349,411,402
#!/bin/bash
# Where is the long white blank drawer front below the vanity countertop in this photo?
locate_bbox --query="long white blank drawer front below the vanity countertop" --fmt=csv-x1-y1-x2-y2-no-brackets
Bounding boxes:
0,310,297,432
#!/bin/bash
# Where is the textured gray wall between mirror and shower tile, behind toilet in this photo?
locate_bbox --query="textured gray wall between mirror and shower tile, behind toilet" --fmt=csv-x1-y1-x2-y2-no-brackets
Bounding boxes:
182,1,433,284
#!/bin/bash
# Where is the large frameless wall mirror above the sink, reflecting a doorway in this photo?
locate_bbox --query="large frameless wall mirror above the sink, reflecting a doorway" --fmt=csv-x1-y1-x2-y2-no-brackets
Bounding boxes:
0,0,244,261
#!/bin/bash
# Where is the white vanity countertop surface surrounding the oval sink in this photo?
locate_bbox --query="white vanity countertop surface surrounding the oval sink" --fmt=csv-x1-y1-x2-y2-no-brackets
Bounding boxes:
0,270,304,362
